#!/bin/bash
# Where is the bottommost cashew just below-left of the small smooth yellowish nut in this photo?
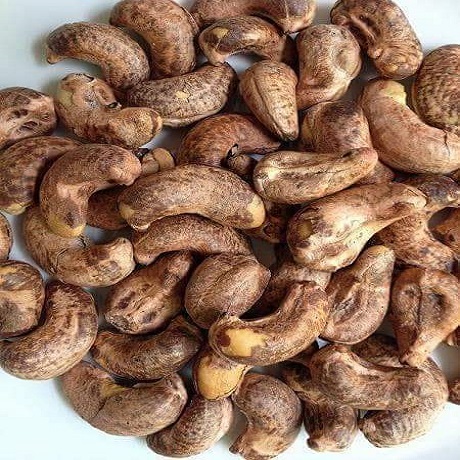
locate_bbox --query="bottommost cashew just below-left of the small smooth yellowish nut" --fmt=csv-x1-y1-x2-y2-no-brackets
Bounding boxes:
147,395,233,457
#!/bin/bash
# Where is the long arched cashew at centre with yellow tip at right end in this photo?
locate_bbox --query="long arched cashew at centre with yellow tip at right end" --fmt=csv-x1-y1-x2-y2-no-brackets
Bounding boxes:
118,165,265,231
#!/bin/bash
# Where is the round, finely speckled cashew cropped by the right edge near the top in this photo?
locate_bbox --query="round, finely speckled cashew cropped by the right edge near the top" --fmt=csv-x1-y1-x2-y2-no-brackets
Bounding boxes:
412,45,460,135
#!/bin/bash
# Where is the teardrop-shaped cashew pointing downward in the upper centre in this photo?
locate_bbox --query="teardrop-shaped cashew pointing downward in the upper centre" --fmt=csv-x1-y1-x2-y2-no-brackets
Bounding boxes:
240,61,299,141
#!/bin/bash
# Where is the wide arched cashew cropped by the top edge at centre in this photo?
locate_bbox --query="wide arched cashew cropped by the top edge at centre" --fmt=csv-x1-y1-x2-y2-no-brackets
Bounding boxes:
191,0,316,33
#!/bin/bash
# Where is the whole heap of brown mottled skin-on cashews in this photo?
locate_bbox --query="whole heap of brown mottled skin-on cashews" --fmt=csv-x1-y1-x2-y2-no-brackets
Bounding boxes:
0,0,460,460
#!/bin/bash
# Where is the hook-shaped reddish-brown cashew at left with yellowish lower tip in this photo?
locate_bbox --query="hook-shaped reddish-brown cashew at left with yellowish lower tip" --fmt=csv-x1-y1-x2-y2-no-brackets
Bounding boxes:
40,144,141,238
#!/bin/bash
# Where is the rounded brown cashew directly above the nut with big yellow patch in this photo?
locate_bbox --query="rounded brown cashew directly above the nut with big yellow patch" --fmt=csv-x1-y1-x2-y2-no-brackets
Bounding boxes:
184,254,270,329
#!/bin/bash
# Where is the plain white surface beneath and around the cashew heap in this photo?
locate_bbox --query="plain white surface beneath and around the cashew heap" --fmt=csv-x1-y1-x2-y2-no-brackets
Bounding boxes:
0,0,460,460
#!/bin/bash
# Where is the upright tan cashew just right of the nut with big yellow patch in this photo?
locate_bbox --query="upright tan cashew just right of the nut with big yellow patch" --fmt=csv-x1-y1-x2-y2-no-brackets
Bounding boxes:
321,246,395,344
